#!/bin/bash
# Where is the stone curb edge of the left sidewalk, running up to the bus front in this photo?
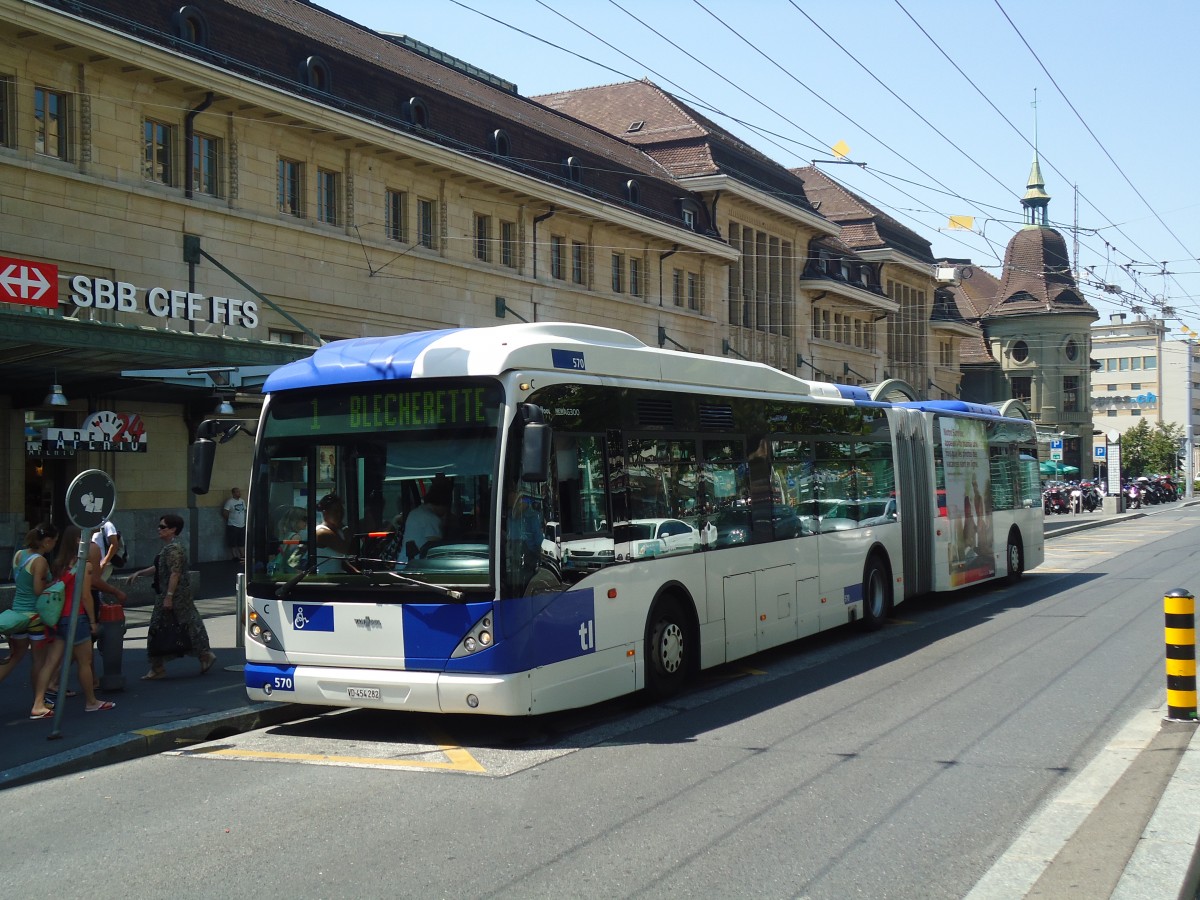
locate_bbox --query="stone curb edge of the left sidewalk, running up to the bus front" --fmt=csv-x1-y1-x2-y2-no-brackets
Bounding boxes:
0,703,326,790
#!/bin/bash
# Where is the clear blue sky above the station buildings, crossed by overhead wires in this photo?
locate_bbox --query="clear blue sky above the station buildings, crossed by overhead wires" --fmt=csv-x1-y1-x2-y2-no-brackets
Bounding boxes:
319,0,1200,331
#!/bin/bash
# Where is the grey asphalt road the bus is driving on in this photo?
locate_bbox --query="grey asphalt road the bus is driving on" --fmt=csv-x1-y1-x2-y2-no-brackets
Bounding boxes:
0,506,1200,900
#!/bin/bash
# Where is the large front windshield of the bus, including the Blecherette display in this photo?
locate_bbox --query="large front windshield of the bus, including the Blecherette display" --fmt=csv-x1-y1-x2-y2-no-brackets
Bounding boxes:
247,379,503,599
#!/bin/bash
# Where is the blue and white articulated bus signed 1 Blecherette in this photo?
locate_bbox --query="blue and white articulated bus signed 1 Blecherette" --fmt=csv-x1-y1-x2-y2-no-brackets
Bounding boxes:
196,323,1043,715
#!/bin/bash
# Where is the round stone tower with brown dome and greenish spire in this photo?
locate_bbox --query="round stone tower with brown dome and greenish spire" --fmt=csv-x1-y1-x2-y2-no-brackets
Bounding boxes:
980,157,1099,474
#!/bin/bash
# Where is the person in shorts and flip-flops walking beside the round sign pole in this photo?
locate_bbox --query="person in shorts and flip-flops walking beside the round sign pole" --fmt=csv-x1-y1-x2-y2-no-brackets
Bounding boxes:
29,526,116,719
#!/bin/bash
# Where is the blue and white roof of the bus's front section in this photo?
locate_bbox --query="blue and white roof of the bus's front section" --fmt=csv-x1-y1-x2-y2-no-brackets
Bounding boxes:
263,322,845,400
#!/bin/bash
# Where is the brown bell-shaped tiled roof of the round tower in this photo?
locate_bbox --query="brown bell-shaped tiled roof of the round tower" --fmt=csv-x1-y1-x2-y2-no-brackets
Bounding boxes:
986,226,1099,319
